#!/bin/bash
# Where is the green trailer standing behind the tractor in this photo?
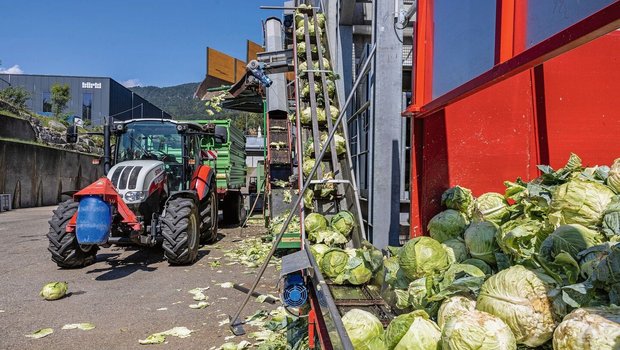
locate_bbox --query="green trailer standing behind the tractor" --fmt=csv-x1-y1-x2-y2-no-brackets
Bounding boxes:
193,119,247,224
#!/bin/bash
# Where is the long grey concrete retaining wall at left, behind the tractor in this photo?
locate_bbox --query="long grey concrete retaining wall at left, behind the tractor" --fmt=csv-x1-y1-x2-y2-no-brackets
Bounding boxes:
0,140,103,208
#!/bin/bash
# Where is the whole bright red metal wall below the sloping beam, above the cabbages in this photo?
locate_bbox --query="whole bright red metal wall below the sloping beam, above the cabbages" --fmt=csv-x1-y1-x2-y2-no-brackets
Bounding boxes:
411,32,620,236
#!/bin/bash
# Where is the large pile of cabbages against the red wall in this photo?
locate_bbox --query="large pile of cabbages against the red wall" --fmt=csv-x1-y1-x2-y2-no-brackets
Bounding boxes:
343,154,620,350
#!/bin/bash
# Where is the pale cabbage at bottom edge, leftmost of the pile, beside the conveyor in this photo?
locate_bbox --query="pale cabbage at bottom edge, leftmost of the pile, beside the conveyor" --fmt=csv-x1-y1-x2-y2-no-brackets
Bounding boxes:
342,309,385,350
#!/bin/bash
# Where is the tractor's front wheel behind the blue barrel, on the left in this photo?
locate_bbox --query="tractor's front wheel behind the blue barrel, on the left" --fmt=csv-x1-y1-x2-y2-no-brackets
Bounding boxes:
47,199,99,268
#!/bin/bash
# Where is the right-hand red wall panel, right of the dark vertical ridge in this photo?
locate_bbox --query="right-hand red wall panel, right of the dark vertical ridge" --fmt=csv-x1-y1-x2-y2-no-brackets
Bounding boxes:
537,31,620,167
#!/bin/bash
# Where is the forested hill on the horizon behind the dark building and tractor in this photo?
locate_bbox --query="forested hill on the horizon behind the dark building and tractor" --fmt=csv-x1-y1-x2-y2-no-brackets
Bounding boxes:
130,83,263,135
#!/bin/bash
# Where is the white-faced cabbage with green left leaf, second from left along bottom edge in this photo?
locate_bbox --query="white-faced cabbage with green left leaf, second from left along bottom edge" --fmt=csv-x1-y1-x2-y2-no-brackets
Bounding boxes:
385,310,441,350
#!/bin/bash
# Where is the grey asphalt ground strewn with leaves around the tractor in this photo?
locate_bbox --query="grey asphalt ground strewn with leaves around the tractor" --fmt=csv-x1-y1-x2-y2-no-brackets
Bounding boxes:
0,207,278,350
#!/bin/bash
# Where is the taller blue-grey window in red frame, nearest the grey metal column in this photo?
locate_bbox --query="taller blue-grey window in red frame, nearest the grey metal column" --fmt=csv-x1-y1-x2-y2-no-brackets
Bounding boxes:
432,0,496,98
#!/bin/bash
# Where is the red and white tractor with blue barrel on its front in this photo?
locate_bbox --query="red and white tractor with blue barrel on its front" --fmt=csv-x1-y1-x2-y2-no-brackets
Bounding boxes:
47,119,220,268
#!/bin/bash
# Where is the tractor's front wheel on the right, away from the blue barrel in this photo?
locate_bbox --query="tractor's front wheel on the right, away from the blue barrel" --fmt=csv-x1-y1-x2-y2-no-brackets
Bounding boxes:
161,198,200,265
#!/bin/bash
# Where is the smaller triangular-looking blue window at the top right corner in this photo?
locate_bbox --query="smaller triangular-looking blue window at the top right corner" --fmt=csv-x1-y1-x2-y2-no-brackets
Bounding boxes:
526,0,616,48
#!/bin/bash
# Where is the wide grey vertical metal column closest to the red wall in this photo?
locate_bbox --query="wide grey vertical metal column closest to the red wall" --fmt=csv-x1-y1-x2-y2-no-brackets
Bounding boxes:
369,0,404,248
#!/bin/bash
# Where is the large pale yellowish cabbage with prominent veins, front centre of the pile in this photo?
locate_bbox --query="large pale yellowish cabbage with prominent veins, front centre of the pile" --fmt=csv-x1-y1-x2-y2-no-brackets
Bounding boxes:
476,265,556,347
